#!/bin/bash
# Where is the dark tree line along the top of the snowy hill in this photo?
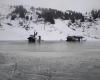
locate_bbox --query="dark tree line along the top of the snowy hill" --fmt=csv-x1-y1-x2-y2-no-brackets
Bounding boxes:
11,5,100,24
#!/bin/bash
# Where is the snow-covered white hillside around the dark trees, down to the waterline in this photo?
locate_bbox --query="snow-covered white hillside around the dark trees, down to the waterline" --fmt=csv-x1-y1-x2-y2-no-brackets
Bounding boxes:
0,7,100,40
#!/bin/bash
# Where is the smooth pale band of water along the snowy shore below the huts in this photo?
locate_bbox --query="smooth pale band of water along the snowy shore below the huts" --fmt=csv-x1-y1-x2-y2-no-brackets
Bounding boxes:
0,41,100,57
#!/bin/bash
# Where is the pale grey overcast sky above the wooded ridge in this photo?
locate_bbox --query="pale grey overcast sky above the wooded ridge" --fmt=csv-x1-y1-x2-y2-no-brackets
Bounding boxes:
0,0,100,12
